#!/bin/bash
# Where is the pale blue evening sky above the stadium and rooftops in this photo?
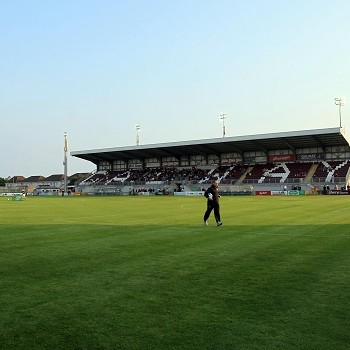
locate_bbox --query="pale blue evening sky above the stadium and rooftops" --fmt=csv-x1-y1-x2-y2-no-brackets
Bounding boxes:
0,0,350,178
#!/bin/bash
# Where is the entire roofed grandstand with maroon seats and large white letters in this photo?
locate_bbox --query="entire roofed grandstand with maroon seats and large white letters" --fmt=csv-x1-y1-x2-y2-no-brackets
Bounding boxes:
71,127,350,194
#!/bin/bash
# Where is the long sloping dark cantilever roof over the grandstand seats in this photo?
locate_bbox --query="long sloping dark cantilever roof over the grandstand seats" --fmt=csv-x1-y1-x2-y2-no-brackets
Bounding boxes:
71,127,350,164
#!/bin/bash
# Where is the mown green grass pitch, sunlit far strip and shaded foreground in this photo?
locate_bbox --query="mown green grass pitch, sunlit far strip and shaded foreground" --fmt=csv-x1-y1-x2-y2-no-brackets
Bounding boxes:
0,196,350,350
